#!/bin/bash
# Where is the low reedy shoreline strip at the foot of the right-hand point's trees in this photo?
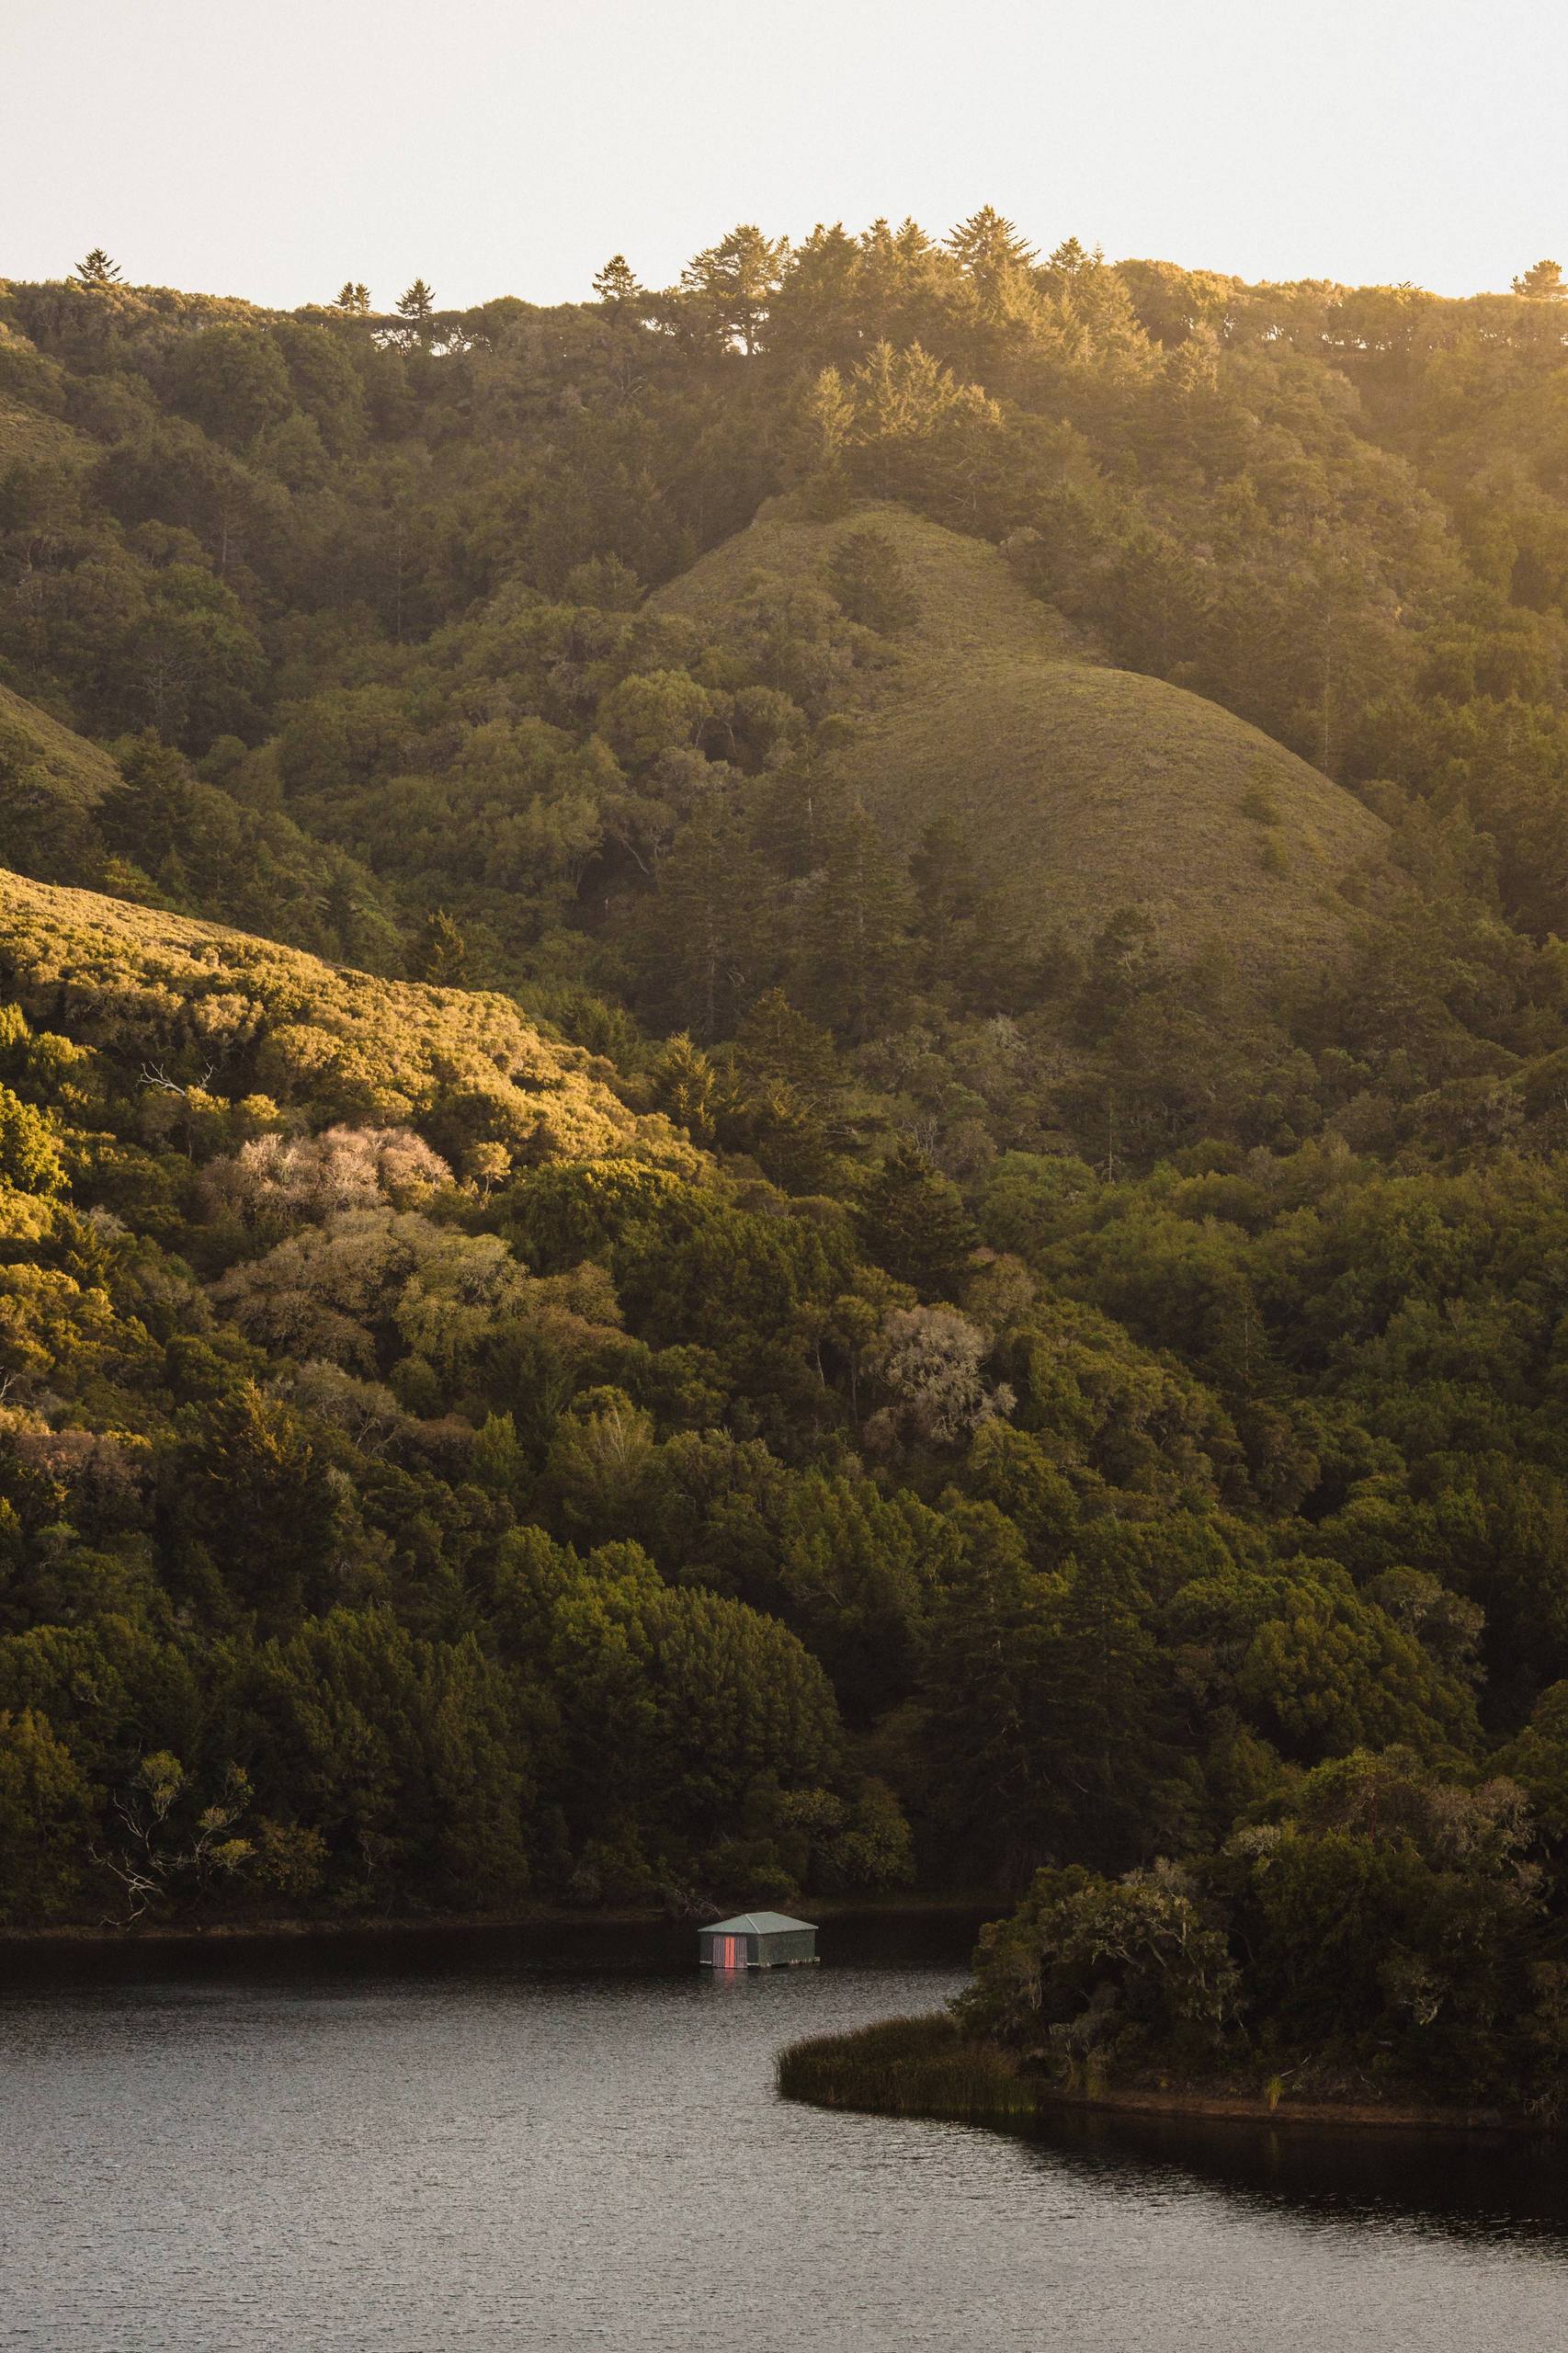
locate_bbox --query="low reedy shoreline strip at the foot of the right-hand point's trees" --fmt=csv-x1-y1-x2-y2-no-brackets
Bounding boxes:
777,2012,1563,2139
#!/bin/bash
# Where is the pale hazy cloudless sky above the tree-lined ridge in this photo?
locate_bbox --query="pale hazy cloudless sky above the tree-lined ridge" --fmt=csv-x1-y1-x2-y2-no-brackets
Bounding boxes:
0,0,1568,303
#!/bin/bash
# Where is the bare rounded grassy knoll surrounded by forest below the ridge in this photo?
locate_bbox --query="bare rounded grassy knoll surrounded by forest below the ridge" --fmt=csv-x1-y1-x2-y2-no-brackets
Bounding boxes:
659,501,1387,965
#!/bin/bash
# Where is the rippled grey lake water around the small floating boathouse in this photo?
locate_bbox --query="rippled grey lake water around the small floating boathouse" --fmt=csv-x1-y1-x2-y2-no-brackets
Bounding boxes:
0,1925,1568,2353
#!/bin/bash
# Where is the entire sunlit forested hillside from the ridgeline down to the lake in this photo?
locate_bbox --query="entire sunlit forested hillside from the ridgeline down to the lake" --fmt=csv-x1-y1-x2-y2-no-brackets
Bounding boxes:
0,229,1568,2118
